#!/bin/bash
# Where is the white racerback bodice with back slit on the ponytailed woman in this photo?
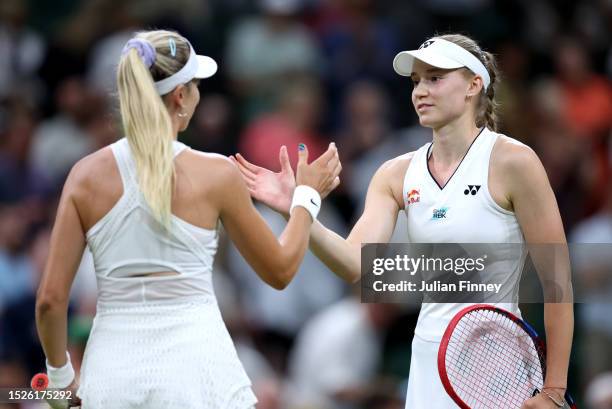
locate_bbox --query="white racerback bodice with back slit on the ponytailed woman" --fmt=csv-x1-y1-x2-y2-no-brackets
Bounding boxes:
86,138,218,303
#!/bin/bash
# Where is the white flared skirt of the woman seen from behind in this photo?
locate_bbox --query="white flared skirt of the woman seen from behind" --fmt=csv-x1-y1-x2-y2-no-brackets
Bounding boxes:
77,298,257,409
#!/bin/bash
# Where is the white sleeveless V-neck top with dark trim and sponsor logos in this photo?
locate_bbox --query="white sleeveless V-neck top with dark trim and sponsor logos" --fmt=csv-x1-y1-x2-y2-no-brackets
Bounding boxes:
403,128,526,341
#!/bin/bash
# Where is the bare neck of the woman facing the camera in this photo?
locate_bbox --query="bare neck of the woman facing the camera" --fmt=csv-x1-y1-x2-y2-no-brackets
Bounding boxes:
432,115,480,165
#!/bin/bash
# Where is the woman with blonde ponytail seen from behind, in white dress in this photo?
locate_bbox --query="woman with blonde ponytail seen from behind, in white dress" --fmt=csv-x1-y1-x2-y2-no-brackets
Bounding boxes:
36,31,340,409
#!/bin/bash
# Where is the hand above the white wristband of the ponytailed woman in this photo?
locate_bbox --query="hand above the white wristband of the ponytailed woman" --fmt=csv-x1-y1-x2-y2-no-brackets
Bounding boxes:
295,143,342,198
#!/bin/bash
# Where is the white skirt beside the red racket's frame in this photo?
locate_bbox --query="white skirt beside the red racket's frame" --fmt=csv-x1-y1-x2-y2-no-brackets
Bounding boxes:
406,335,459,409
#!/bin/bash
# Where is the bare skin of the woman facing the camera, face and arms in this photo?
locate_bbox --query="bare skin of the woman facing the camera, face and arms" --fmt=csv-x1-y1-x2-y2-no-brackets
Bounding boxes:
232,60,574,409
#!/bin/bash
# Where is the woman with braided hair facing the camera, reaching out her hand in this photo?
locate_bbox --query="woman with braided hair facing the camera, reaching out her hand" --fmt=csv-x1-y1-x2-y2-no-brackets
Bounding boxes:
234,34,573,409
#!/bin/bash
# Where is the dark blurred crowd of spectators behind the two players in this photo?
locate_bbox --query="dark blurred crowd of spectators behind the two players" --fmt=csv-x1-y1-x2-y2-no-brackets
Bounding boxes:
0,0,612,409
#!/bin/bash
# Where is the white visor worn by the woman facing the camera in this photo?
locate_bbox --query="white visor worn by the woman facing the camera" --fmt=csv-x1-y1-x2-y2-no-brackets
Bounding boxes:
393,38,491,90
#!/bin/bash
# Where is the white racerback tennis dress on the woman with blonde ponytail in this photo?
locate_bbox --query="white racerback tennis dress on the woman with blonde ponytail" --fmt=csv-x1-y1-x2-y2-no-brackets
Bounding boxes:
77,138,257,409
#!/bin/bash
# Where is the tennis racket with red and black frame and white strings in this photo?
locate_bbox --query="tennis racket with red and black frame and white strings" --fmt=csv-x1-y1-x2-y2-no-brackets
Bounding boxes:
438,304,576,409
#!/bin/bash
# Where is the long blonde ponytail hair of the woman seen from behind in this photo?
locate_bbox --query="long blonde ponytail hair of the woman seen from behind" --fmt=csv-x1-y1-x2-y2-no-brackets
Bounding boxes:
117,30,189,228
